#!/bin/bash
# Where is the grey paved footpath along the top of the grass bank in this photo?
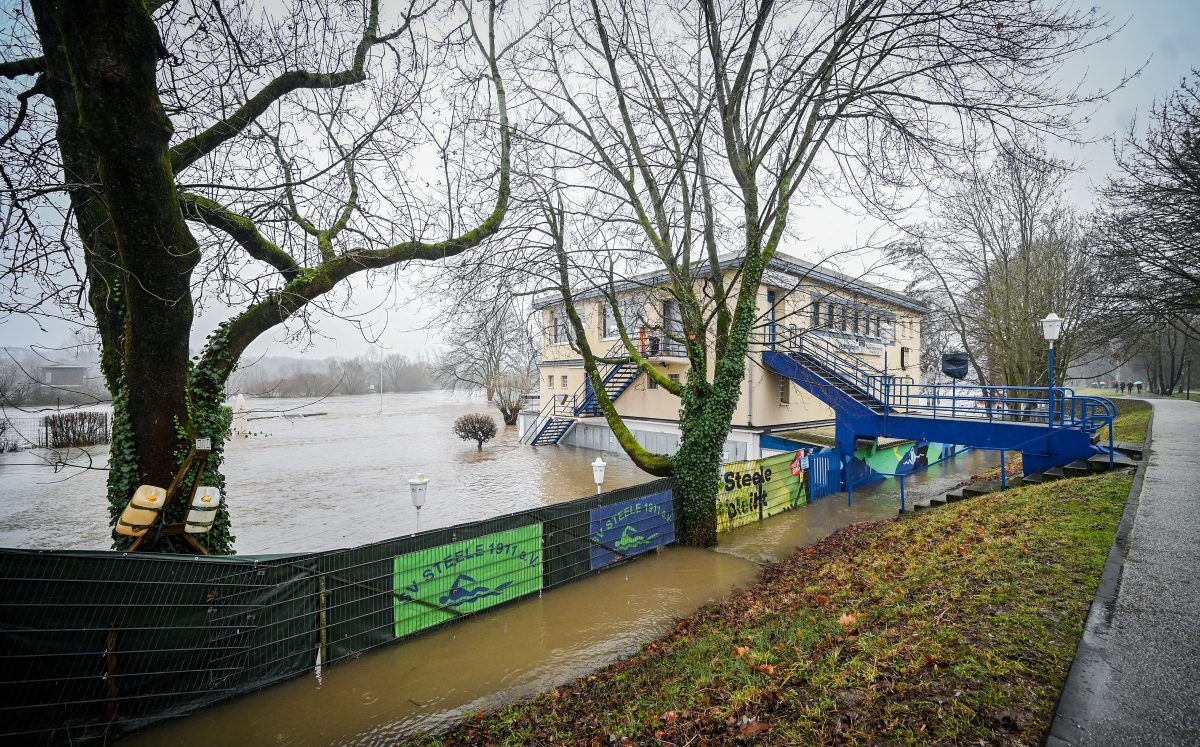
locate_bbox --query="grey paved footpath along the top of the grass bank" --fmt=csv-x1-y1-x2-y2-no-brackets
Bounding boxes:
1046,399,1200,747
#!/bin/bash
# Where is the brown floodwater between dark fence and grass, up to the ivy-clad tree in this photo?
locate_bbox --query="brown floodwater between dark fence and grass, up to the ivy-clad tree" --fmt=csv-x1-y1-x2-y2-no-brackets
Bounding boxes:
120,548,757,747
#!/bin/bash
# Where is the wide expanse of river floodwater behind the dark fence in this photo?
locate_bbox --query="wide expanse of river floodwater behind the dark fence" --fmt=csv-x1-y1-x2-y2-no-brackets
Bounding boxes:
0,392,652,554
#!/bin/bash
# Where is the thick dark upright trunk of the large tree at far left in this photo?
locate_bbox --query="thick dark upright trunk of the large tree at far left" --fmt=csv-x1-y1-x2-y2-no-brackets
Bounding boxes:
32,0,206,547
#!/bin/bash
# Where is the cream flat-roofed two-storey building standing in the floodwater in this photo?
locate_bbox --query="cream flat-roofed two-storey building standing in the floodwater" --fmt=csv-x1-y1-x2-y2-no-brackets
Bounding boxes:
521,256,928,461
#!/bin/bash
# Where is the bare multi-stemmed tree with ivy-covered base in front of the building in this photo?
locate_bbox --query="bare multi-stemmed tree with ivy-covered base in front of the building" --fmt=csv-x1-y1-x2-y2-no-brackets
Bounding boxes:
522,0,1103,545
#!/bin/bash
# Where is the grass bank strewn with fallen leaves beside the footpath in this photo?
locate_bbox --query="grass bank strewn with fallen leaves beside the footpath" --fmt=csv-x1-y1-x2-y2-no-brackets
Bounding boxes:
427,474,1130,745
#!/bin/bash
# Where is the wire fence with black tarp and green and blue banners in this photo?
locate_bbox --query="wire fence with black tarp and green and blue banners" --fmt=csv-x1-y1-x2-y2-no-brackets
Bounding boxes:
0,479,676,745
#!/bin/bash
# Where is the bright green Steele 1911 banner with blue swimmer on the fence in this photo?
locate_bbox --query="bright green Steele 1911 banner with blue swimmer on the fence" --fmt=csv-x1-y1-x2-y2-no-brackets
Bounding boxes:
392,524,542,638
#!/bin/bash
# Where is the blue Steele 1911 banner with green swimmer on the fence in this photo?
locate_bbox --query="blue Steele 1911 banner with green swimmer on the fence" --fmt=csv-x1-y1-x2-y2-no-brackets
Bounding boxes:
588,490,674,570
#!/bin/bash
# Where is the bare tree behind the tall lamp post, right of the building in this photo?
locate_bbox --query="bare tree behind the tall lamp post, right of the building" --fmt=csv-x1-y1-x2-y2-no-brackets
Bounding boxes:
893,147,1114,396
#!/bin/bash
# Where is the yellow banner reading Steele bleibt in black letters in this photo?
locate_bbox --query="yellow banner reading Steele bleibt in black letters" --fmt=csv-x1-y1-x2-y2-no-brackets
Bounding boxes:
716,450,809,532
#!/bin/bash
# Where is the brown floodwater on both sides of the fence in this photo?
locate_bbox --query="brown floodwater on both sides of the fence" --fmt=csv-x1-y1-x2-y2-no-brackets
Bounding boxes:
0,393,997,746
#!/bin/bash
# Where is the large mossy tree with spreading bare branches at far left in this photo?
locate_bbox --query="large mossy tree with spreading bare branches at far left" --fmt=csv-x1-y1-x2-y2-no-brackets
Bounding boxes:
0,0,509,552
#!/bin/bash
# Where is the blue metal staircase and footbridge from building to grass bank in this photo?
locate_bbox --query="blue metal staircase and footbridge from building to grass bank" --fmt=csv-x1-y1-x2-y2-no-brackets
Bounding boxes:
762,333,1116,474
